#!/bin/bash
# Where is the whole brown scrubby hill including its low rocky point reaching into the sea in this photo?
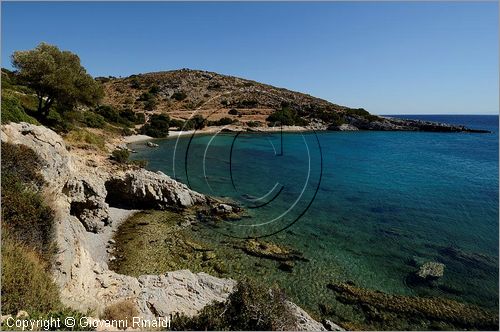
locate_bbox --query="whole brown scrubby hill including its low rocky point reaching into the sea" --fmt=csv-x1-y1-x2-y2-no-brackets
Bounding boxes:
97,69,483,132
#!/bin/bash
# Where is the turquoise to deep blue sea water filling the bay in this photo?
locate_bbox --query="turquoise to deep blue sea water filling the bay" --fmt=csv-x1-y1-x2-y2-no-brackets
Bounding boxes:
131,116,499,310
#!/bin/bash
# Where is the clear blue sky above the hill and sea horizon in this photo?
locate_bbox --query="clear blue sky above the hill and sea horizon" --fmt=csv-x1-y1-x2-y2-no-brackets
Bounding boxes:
2,2,499,114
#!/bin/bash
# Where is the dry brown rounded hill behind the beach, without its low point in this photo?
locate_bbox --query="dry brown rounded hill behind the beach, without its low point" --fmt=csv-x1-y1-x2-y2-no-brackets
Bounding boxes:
98,69,368,125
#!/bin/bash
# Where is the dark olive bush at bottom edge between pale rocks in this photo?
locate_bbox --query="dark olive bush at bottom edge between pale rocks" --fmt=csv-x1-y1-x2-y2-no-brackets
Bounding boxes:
172,281,297,331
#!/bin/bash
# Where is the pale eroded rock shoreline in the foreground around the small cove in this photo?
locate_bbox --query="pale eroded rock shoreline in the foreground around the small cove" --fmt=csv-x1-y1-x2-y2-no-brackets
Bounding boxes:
1,123,324,330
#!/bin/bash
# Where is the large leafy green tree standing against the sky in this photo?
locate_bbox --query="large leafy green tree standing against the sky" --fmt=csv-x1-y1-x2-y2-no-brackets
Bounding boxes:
12,43,104,116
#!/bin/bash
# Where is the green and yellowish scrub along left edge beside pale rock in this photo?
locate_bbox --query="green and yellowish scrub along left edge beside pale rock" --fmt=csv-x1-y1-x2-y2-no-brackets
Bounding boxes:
1,142,60,314
